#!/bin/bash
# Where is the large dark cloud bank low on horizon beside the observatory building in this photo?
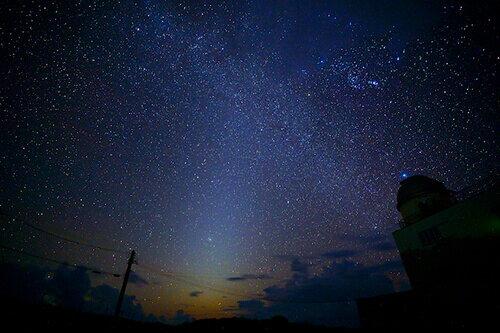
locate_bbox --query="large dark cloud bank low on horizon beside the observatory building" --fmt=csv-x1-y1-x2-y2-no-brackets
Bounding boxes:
238,260,396,326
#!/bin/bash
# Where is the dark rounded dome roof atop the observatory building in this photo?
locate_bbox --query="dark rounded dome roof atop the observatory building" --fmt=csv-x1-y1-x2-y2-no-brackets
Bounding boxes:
397,175,450,209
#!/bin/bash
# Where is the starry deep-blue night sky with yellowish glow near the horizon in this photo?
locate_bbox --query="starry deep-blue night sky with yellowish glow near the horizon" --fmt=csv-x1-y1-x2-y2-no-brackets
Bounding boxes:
0,0,499,325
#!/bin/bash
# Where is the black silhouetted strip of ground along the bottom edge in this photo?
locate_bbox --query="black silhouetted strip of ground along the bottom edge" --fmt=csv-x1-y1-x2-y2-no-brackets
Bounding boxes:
1,303,356,333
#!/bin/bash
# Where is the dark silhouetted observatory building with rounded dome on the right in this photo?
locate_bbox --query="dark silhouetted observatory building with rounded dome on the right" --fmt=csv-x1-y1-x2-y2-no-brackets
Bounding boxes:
357,176,500,328
